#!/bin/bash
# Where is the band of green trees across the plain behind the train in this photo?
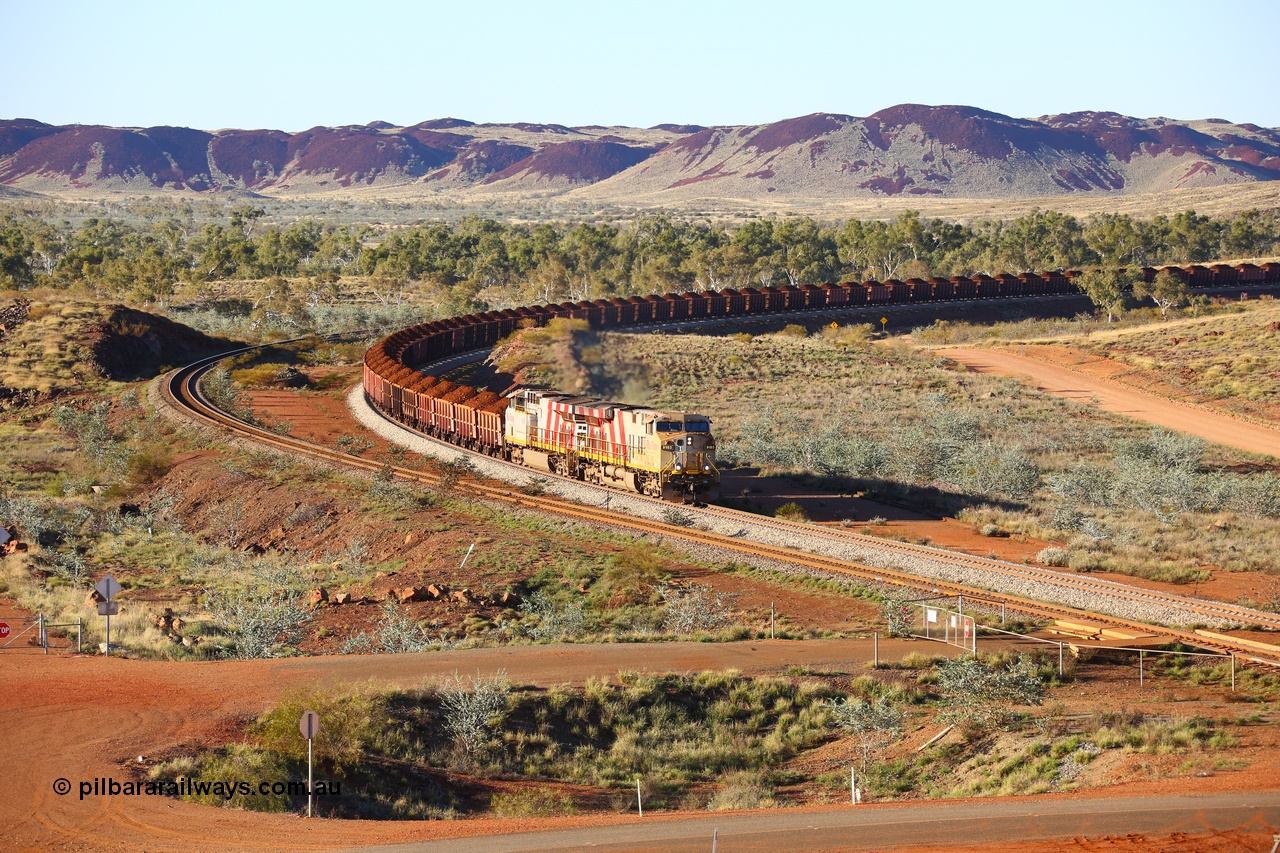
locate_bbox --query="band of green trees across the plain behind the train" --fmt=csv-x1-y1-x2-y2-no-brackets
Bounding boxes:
0,205,1280,313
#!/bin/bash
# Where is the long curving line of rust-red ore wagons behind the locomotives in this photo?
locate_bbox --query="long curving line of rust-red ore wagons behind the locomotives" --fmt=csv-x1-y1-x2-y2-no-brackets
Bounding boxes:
364,263,1280,493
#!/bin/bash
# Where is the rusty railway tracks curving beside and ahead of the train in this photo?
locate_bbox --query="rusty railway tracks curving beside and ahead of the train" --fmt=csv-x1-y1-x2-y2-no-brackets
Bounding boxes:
163,343,1280,669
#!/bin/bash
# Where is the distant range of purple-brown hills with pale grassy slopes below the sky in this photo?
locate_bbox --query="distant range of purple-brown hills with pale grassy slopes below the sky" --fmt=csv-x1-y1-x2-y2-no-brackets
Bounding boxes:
0,104,1280,202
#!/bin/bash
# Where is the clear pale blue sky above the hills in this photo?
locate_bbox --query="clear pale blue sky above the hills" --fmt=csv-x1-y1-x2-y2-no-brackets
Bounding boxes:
10,0,1280,131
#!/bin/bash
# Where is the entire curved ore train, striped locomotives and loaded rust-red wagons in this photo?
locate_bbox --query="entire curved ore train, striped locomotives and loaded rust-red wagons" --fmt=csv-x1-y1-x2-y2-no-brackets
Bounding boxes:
364,258,1280,502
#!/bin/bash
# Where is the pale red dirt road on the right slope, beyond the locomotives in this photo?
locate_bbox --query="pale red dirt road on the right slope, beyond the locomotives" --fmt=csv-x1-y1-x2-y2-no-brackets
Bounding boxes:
940,348,1280,456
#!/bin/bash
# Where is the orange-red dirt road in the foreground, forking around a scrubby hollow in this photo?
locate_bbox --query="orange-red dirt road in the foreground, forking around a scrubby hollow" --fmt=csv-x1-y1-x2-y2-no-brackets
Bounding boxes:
10,640,1275,853
